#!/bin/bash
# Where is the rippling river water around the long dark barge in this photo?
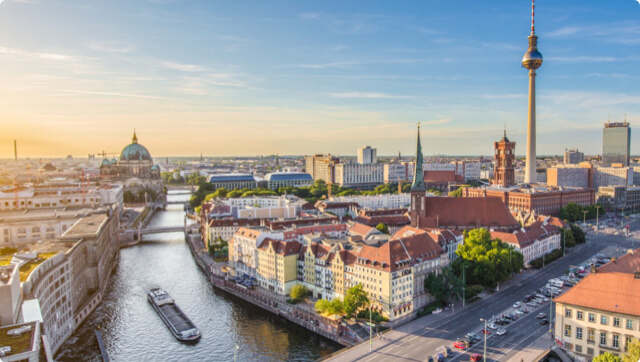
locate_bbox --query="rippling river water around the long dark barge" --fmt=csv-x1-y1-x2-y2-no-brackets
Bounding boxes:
56,194,341,362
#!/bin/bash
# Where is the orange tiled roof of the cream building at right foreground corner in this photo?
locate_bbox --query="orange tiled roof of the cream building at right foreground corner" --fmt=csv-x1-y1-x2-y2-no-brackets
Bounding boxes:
554,270,640,316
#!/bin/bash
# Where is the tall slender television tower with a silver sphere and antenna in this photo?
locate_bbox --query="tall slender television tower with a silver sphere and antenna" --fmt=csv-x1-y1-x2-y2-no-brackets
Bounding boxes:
522,0,542,184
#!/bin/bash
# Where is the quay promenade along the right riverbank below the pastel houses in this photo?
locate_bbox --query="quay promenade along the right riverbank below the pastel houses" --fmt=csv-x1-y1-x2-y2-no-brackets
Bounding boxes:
187,235,362,347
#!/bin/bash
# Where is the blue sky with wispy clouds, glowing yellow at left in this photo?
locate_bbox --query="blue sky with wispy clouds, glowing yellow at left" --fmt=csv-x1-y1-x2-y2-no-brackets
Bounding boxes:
0,0,640,157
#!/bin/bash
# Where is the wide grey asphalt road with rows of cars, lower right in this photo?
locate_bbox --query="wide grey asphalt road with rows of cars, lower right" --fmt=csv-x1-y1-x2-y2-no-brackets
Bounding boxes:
344,235,616,362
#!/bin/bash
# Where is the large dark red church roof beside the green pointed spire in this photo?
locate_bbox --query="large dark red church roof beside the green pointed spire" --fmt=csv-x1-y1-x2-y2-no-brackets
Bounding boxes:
420,196,519,228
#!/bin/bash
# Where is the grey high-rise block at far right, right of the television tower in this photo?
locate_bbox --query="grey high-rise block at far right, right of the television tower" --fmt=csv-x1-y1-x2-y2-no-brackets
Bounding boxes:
602,120,631,166
